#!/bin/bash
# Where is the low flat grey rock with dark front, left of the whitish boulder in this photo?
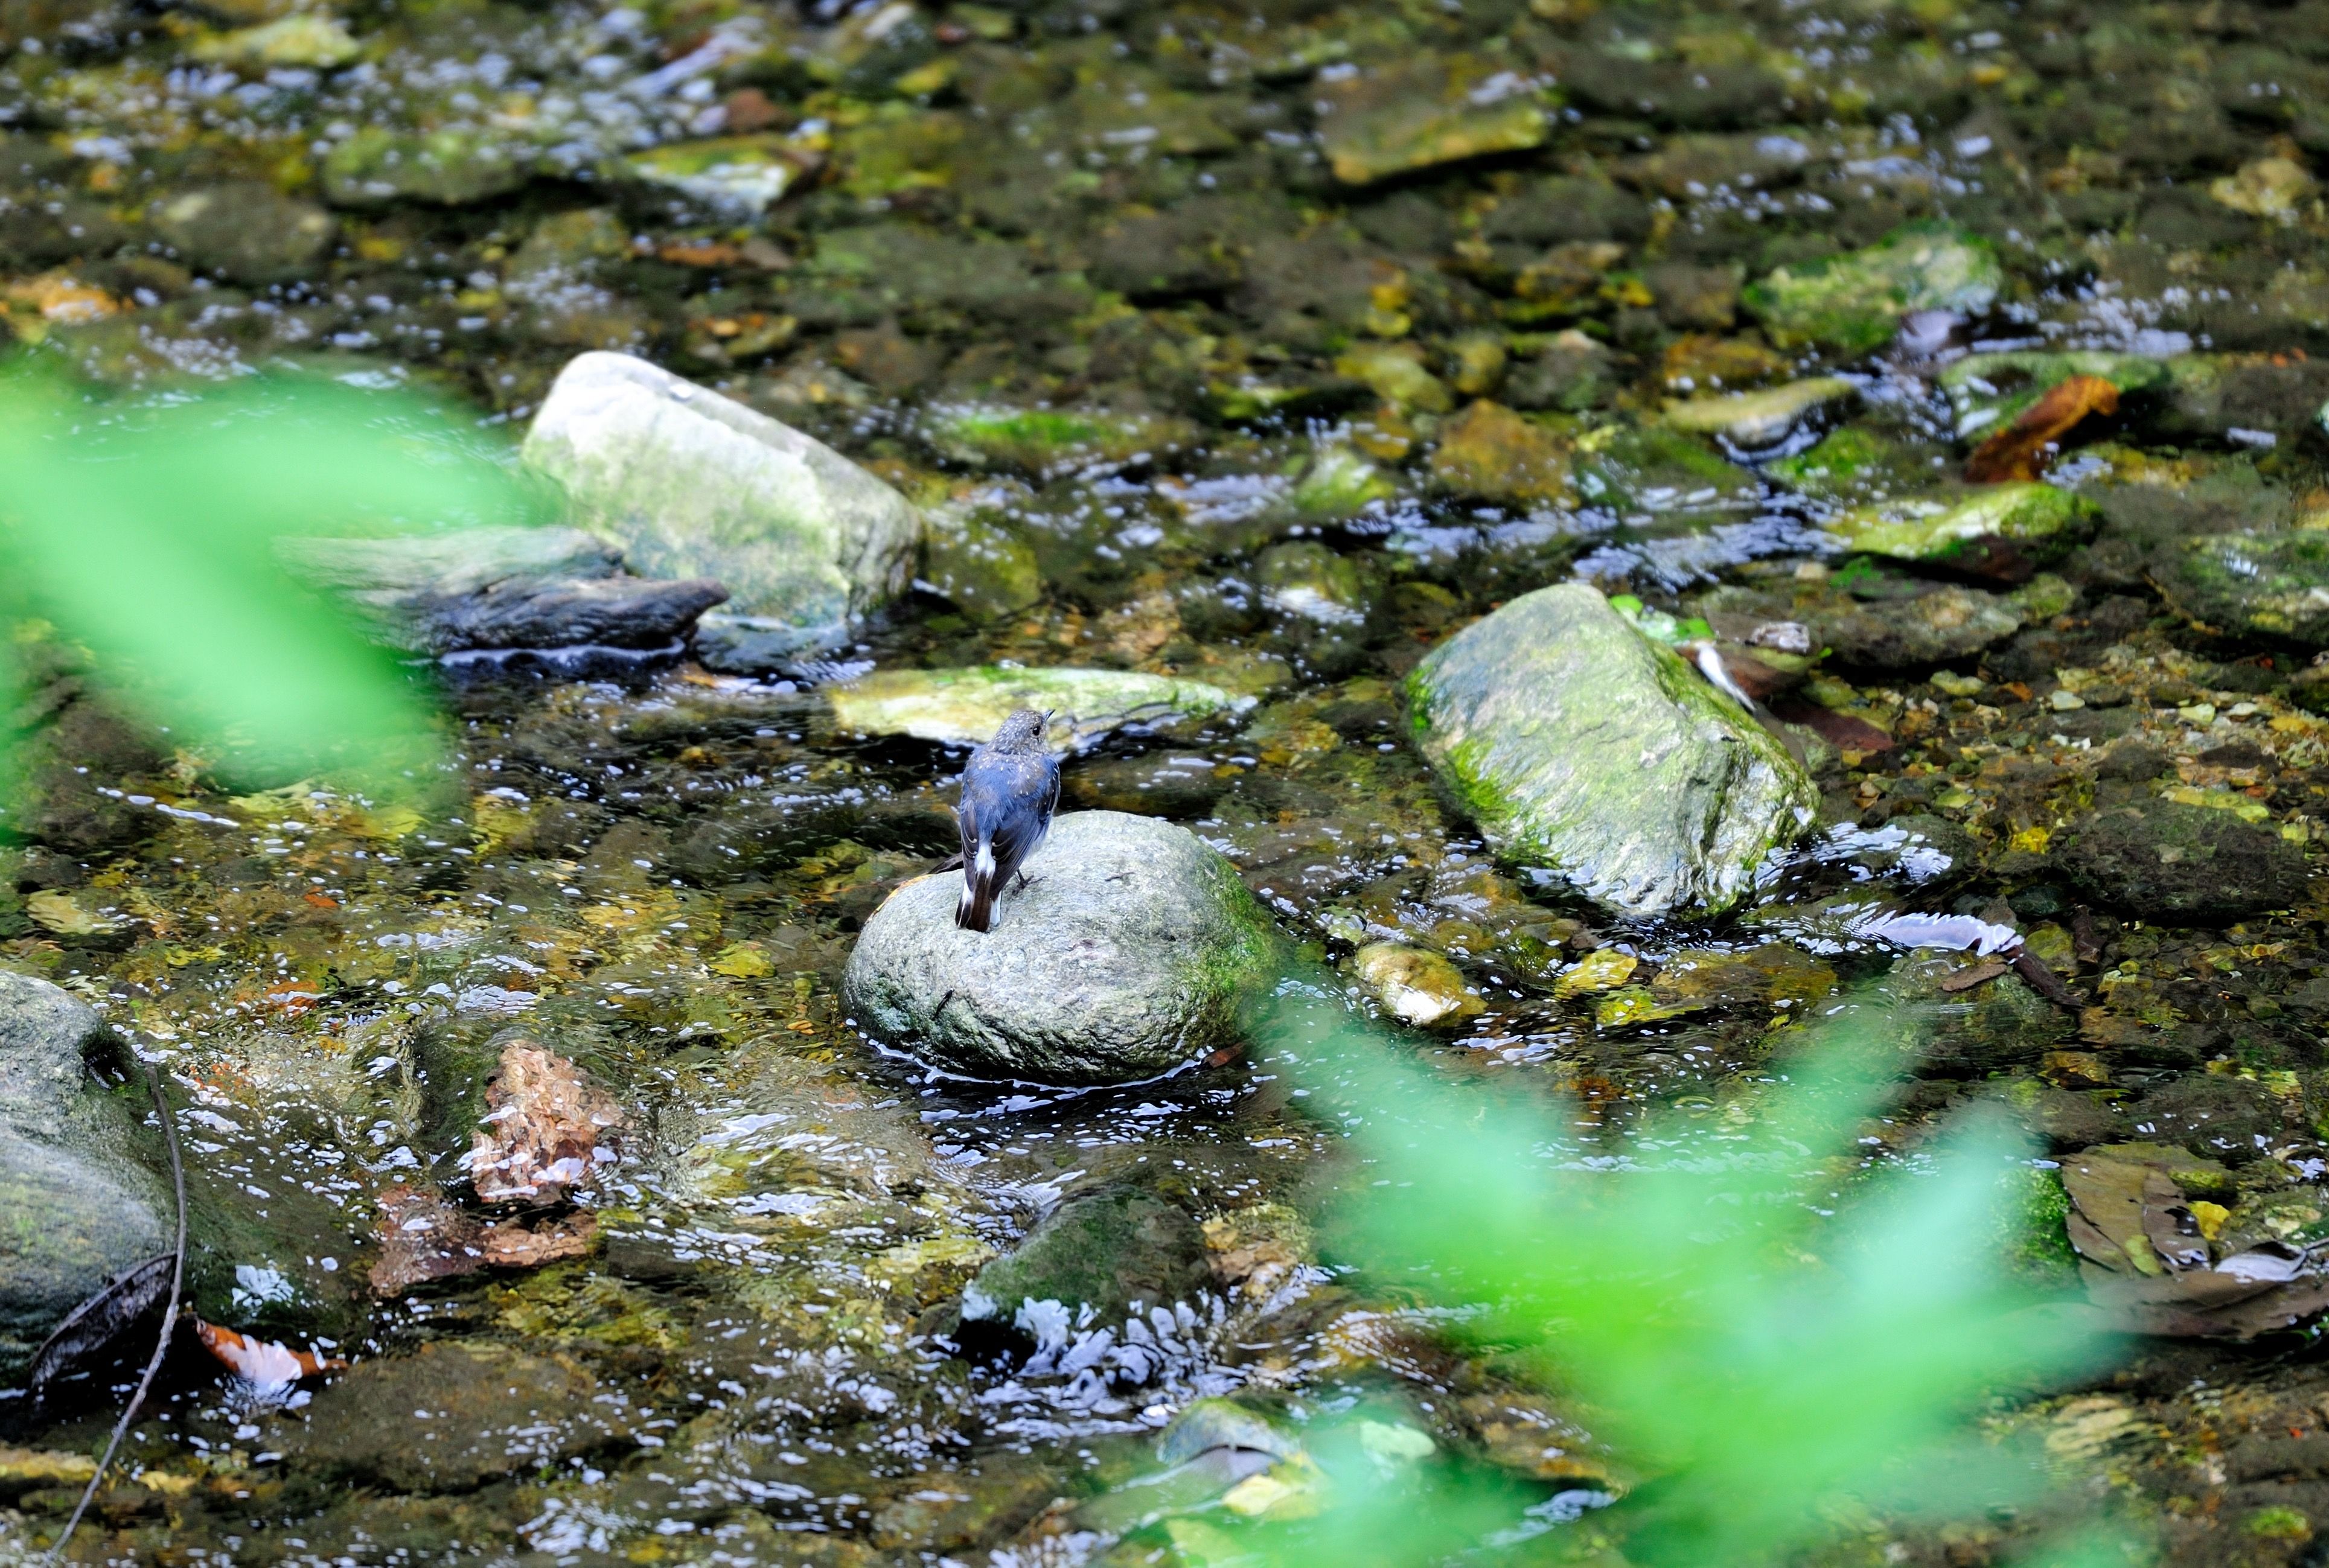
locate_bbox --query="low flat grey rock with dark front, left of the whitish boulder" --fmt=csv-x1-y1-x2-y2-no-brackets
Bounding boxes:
282,529,727,655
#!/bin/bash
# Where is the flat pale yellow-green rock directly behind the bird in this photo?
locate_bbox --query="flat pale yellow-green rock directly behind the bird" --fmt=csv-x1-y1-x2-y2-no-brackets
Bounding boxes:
827,664,1251,750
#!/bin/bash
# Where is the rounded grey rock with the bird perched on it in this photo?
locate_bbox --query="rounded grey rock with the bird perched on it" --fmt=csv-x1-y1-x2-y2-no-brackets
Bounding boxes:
843,811,1276,1083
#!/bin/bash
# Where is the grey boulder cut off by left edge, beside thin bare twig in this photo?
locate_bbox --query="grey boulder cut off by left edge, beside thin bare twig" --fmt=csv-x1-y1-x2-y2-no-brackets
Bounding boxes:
0,972,170,1382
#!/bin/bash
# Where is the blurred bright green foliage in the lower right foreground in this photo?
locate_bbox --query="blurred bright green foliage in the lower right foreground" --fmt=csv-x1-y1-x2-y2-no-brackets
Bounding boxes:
1241,978,2112,1566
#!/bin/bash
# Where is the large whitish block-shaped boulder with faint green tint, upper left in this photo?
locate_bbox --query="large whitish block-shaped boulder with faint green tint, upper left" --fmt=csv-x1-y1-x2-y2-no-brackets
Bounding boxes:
524,352,922,669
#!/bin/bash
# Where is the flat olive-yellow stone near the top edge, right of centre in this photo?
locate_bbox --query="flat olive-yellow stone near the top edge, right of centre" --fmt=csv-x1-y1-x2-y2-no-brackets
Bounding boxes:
1318,54,1547,184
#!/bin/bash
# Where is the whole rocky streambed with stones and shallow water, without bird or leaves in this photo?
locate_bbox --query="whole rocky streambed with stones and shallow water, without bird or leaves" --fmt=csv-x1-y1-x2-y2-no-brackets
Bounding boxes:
0,0,2329,1563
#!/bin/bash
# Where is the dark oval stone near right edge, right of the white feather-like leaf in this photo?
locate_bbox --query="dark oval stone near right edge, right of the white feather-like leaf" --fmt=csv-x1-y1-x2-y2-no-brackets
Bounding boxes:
2054,799,2308,925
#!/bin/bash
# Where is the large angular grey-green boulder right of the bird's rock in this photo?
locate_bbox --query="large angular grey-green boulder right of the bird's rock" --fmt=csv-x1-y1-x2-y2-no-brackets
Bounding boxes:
1407,582,1819,916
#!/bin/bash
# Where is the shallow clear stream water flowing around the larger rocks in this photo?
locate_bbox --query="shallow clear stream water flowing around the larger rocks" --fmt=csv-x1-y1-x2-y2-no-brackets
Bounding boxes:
0,0,2329,1566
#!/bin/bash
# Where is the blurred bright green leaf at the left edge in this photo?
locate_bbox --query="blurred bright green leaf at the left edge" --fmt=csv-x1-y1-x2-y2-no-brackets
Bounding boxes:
0,359,538,774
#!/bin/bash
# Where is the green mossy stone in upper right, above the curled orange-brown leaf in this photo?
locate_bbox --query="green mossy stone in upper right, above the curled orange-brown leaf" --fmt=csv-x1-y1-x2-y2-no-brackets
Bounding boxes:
1740,221,2005,354
